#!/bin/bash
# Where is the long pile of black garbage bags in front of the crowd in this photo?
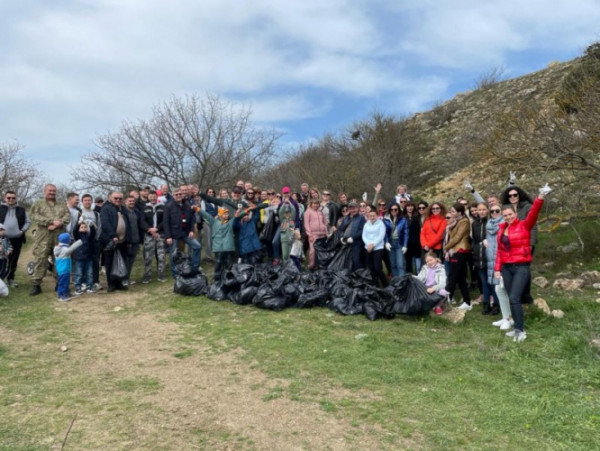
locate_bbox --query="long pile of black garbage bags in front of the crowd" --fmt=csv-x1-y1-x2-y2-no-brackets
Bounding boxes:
174,249,440,320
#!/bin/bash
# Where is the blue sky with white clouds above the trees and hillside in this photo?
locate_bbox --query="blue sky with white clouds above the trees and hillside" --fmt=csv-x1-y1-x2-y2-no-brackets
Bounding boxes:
0,0,600,184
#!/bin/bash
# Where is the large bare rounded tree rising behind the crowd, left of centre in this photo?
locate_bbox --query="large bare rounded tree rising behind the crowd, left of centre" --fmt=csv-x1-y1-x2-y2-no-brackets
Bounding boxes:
73,95,280,192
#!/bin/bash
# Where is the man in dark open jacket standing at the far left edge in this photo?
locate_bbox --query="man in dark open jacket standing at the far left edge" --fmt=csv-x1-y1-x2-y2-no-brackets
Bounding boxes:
0,190,31,288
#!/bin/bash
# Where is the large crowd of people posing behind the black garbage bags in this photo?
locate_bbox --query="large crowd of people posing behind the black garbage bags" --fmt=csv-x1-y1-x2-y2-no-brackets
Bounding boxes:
0,177,550,341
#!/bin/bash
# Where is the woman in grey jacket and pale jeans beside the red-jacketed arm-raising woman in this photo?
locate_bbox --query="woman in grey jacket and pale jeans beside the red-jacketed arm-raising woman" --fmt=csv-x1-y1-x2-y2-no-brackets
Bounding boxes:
483,205,513,330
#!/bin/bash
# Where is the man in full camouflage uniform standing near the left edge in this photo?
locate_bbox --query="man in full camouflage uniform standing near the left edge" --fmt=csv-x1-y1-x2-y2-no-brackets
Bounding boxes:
29,184,71,296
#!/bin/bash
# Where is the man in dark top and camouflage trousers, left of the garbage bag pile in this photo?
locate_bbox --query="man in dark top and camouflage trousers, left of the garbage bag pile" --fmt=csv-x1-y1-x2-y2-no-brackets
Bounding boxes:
142,191,166,283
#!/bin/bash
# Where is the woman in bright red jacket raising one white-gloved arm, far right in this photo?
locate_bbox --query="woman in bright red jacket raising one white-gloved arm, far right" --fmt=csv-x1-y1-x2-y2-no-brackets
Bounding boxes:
494,184,551,341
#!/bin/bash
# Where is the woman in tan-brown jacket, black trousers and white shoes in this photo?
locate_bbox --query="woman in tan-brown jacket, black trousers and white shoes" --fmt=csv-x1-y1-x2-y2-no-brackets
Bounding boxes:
444,202,473,311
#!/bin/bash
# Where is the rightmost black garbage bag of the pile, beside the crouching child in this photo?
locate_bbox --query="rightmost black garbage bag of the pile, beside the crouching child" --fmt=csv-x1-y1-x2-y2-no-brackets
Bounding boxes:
385,275,440,315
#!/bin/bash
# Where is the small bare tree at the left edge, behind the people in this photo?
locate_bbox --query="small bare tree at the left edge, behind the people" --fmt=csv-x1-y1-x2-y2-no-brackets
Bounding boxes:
0,142,43,201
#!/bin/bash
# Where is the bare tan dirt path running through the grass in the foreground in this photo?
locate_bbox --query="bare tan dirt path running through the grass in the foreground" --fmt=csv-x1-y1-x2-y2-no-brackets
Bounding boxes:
57,290,381,450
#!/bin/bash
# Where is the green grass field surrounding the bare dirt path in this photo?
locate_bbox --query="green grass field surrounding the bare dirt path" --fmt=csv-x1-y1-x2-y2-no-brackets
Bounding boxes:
0,224,600,450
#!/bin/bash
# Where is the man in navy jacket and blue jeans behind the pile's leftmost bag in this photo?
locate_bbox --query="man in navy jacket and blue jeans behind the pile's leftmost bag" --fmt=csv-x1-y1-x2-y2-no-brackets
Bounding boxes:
163,190,202,277
